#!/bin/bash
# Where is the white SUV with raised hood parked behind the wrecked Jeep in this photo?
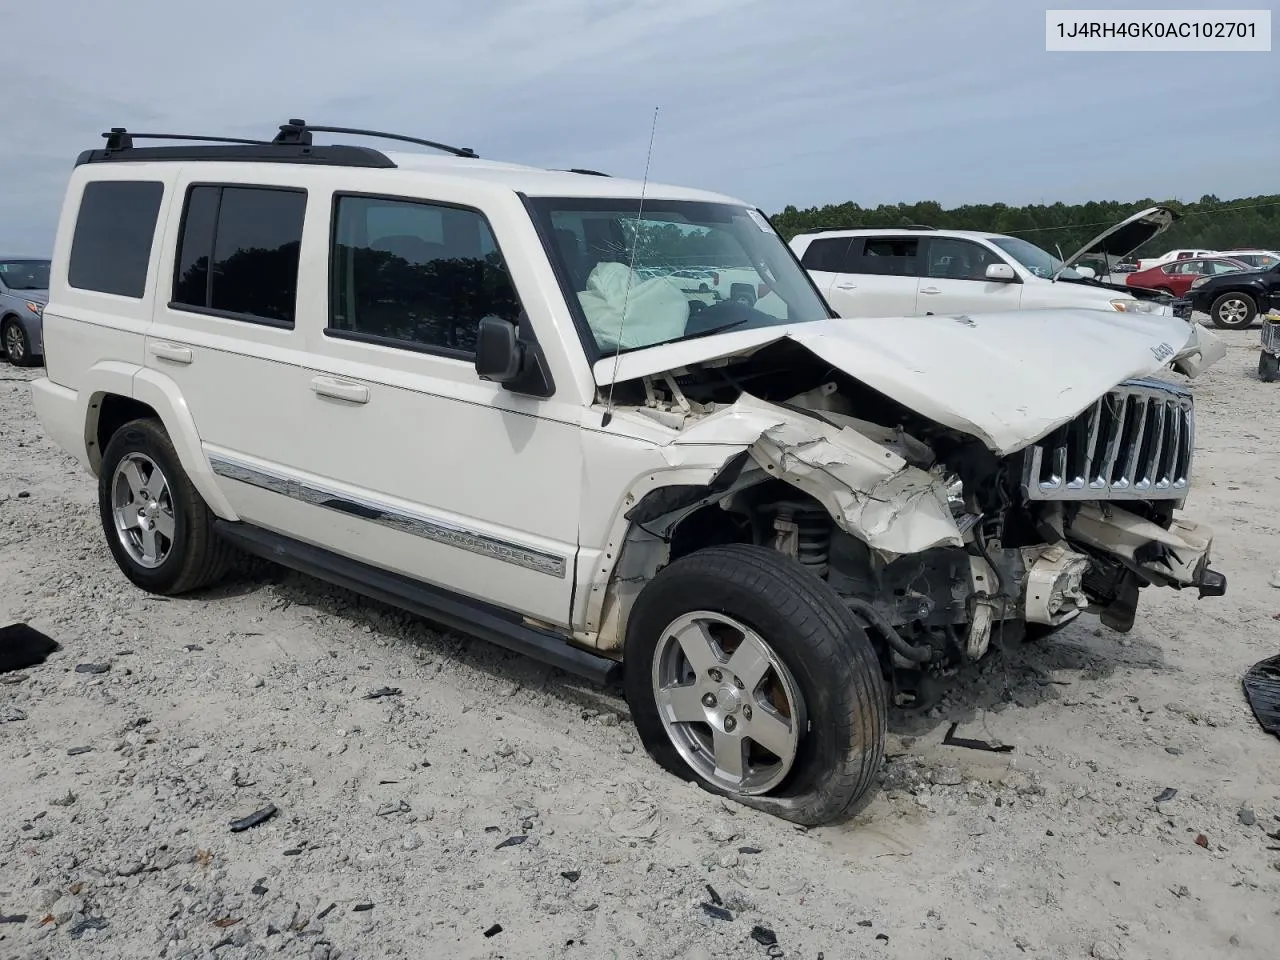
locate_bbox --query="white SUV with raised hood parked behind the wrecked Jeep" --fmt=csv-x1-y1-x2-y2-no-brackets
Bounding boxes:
791,207,1208,327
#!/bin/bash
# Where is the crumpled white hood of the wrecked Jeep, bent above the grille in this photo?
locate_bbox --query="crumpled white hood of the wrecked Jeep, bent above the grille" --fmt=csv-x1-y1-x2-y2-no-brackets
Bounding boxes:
595,310,1222,454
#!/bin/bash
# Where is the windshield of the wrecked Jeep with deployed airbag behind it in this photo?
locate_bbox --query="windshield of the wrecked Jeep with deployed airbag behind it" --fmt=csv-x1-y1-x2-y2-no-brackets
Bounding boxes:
530,198,832,358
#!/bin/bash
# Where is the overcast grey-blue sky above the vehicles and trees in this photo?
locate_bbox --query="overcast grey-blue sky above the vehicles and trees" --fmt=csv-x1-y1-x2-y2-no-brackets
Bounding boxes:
0,0,1280,253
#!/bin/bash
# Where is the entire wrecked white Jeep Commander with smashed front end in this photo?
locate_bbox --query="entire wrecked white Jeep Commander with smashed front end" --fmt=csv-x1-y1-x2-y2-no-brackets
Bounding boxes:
33,120,1225,823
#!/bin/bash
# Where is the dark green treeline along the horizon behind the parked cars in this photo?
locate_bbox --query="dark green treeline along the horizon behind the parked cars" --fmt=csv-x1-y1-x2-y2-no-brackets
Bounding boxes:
771,193,1280,256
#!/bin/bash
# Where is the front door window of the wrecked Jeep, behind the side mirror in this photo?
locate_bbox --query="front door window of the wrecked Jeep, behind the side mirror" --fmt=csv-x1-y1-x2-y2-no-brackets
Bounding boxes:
329,196,521,357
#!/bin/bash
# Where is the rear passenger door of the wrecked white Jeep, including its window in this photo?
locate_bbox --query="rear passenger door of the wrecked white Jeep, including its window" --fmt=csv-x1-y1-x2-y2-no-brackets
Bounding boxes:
145,176,313,536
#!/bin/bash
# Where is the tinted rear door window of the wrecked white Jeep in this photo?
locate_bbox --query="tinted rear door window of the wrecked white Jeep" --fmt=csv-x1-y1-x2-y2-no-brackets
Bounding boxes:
173,186,307,328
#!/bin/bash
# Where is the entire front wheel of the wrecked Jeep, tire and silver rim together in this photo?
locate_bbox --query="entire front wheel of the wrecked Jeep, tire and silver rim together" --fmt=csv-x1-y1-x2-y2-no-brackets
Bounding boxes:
625,544,888,826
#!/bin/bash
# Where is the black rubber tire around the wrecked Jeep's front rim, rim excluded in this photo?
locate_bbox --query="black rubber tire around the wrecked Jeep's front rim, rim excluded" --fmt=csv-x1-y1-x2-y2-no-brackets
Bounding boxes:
623,544,888,826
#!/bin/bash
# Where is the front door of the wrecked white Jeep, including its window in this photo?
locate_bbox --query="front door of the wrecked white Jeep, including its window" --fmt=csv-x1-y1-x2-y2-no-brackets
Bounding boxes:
285,193,582,626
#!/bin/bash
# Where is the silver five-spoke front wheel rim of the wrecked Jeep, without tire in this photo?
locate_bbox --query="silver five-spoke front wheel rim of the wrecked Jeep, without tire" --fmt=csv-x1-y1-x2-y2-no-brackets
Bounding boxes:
653,611,805,795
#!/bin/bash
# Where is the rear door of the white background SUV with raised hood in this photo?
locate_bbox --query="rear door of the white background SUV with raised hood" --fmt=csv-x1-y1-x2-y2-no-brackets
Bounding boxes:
828,234,922,316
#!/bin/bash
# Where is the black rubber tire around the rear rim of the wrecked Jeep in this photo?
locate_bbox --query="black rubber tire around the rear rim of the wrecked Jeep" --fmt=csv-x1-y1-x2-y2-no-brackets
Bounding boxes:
97,419,234,595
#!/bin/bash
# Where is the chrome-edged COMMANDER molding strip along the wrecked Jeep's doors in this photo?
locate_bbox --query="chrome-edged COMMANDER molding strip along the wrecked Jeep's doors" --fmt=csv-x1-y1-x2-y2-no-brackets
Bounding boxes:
209,453,568,580
